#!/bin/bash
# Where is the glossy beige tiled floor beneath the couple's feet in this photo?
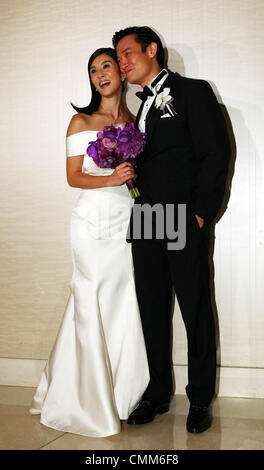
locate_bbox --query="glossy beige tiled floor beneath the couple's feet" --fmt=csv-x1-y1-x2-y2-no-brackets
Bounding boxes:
0,386,264,450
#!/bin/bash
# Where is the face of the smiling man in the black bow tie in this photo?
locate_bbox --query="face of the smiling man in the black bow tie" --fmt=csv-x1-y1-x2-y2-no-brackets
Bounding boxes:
116,34,153,86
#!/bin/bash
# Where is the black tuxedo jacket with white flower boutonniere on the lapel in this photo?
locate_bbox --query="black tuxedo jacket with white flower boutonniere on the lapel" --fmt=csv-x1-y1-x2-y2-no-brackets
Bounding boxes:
136,72,230,221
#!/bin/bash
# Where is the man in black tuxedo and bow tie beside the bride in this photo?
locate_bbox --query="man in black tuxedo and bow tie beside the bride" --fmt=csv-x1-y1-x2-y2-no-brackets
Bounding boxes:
113,27,230,433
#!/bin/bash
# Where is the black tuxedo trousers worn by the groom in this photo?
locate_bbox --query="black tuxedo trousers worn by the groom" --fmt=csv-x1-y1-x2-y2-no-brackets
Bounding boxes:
132,214,216,406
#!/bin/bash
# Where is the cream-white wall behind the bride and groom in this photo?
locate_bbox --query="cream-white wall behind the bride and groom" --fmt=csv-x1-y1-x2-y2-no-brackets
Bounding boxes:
0,0,264,397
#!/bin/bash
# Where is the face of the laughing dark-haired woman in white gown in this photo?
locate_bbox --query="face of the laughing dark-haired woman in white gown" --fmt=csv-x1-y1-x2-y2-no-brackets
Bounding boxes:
90,54,122,96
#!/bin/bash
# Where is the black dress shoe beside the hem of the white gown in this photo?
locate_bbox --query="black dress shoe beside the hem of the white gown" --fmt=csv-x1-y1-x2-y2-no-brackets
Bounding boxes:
127,400,170,424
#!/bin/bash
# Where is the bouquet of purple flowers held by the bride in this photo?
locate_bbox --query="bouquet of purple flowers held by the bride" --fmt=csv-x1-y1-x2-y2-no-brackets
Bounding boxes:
86,122,146,198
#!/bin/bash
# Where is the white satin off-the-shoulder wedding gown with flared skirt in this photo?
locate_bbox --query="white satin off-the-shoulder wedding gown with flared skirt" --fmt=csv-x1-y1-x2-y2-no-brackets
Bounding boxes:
30,131,149,437
